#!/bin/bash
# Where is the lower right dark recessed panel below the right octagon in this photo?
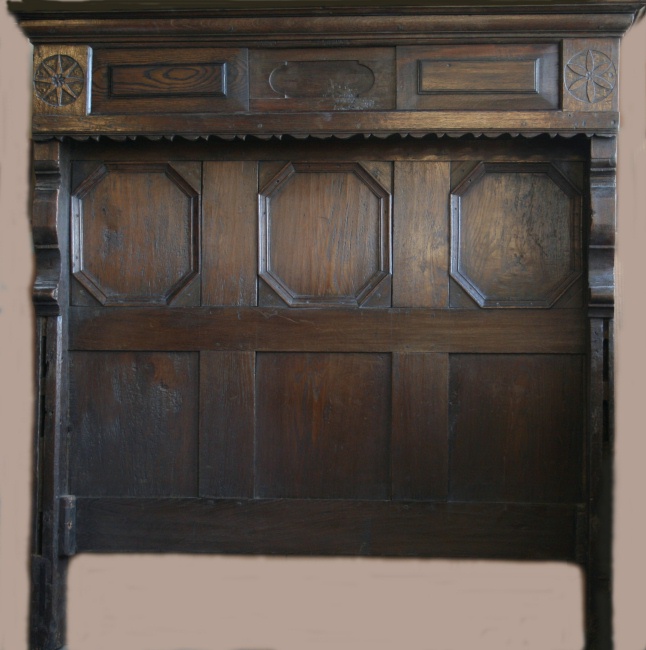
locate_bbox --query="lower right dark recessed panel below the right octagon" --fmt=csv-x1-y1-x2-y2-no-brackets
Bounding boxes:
450,355,585,502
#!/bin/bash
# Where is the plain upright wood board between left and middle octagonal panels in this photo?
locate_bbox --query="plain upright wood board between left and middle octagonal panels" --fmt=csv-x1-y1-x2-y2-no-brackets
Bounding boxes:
202,161,258,306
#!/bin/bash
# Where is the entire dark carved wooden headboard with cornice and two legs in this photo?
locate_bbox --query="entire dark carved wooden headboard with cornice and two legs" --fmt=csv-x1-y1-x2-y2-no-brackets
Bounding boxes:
10,0,643,650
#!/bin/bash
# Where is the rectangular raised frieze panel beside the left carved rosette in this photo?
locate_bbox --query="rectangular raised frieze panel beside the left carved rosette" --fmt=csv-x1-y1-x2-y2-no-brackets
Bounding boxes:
92,48,249,114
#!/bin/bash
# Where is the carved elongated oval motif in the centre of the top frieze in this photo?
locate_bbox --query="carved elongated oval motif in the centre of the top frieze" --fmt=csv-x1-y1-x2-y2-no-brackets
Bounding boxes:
269,61,375,99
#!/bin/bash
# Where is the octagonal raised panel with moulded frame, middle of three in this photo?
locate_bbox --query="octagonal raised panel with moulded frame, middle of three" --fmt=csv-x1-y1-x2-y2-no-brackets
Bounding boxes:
259,163,391,307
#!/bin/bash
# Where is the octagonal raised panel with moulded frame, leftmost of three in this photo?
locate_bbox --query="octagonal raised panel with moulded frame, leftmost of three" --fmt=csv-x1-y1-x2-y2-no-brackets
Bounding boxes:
72,163,199,305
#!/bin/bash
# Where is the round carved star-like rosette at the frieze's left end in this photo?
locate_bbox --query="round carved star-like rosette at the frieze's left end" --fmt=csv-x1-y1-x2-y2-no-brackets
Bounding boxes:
34,54,85,108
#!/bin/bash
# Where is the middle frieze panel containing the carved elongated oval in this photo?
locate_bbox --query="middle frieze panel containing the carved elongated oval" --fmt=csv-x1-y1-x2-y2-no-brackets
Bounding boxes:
250,47,396,112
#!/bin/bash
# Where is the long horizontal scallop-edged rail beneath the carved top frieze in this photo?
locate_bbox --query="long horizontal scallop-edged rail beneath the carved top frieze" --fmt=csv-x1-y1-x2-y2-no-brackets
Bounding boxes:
32,110,619,138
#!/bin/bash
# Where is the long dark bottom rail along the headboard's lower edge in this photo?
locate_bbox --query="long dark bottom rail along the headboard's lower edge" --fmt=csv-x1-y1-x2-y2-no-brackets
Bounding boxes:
76,497,577,561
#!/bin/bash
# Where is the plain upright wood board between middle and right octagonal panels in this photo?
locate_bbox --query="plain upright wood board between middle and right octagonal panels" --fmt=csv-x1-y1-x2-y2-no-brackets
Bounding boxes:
393,162,451,309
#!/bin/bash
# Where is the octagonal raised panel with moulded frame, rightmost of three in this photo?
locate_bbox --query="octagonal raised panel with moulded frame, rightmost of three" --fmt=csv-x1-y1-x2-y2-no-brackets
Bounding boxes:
451,163,581,308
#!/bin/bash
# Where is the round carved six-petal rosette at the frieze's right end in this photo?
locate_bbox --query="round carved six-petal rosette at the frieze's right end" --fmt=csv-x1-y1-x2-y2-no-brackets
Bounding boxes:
564,50,617,104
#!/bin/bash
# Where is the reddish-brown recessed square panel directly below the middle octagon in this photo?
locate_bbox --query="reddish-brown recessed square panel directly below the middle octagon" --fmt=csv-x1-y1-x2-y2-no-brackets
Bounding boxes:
256,353,391,499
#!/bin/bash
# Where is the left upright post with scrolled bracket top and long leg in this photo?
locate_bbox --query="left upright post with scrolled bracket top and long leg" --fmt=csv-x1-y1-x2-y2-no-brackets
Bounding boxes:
29,142,70,648
